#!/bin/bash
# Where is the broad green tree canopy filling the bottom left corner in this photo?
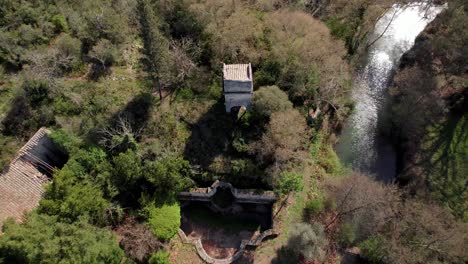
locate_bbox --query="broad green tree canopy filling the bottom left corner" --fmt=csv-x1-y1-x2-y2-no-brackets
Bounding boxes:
0,213,124,264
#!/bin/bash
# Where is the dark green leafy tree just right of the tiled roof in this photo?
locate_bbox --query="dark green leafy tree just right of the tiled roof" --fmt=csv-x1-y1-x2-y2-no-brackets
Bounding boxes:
39,146,118,224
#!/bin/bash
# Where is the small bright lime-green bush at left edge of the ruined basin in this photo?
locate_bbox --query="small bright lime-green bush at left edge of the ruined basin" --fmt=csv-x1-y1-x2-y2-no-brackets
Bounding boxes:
146,203,180,241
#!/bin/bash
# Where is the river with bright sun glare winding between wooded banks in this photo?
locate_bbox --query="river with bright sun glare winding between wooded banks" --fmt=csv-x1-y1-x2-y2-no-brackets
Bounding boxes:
337,4,445,182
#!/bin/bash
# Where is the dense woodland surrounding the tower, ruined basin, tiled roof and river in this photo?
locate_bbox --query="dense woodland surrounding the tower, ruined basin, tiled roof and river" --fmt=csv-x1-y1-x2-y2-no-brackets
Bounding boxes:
0,0,468,263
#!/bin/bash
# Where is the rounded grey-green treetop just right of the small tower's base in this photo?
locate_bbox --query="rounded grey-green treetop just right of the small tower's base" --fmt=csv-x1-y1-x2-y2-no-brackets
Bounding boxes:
252,86,292,117
